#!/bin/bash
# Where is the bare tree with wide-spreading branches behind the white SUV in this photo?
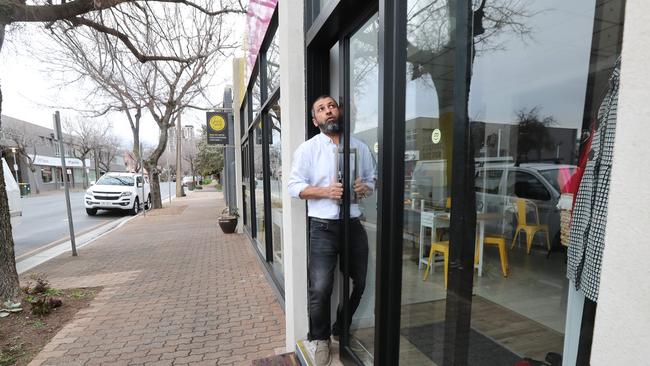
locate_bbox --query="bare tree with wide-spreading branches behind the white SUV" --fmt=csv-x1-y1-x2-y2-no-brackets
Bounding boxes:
45,5,235,208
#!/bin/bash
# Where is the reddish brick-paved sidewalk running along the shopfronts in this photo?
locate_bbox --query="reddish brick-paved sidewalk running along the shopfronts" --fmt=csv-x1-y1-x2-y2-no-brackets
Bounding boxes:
23,191,284,365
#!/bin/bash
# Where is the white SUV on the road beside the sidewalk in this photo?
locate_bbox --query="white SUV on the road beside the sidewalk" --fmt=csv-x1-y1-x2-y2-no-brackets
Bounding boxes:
84,173,151,216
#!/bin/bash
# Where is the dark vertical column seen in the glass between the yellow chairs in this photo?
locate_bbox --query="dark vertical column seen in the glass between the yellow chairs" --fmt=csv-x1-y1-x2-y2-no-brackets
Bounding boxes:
443,0,476,366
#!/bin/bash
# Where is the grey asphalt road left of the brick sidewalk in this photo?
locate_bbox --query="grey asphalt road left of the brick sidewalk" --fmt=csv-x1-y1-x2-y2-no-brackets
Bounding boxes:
13,182,175,257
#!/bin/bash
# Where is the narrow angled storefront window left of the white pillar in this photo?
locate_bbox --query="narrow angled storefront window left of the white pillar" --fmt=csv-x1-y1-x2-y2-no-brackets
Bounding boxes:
240,10,284,293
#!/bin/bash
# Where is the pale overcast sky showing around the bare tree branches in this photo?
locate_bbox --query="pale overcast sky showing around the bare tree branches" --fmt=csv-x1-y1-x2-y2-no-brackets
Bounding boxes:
0,17,243,149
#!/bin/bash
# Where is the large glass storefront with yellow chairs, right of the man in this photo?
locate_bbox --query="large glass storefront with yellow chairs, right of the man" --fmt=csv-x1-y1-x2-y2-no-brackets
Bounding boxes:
306,0,625,365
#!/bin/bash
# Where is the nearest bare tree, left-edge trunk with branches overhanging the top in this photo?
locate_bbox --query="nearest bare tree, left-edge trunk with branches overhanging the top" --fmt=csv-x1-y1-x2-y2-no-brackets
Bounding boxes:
0,0,245,299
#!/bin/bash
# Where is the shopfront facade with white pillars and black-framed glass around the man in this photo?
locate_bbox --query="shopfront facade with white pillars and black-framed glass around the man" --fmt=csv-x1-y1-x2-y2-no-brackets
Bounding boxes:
233,0,650,365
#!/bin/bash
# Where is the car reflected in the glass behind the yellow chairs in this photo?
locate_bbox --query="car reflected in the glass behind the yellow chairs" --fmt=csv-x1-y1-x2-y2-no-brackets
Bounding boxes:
474,164,576,246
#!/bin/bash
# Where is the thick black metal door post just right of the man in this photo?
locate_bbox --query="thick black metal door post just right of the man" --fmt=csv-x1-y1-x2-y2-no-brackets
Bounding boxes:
375,0,407,365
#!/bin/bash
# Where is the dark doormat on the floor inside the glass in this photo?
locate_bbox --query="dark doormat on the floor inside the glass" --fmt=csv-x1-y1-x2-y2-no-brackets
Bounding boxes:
400,322,521,366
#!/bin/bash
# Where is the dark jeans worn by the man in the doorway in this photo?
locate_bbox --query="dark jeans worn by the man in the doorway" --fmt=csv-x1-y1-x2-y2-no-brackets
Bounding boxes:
307,218,368,340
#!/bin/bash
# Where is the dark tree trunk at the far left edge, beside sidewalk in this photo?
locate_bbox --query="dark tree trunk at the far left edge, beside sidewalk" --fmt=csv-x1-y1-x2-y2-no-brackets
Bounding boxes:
0,64,20,301
